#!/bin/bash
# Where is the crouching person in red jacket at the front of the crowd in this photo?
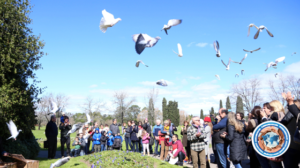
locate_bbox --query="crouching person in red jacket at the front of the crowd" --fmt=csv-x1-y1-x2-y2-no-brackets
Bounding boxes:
165,134,186,166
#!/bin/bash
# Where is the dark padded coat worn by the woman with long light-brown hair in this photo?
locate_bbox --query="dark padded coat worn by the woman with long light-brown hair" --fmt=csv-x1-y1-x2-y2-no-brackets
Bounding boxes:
225,125,247,162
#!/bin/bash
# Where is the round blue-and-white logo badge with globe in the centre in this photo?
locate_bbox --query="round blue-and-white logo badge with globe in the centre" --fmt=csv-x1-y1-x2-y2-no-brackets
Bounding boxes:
252,121,291,158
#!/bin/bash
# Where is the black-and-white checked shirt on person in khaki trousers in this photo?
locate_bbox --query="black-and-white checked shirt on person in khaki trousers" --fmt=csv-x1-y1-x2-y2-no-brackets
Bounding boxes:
187,125,206,151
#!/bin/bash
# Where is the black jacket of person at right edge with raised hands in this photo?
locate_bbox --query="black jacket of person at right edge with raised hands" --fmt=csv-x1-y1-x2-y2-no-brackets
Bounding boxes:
281,111,300,151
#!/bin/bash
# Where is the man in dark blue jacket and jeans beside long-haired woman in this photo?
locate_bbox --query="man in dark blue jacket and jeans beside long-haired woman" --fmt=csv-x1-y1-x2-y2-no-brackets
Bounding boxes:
213,108,229,168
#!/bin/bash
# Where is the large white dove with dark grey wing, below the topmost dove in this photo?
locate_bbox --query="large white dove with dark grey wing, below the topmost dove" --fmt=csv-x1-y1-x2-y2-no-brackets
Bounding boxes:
132,34,161,54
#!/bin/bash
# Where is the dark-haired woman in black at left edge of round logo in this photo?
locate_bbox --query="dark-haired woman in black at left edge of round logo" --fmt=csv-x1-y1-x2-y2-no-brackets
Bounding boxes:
245,106,261,168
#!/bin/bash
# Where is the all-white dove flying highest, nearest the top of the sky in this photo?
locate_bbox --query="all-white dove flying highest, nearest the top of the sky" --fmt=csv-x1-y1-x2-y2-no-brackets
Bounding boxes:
99,9,121,33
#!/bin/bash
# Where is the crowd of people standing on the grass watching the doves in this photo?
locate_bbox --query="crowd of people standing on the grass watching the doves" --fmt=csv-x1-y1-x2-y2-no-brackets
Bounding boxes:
46,93,300,168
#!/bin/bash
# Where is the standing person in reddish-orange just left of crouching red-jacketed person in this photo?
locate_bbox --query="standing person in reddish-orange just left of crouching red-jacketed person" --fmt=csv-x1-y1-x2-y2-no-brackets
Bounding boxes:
158,120,171,160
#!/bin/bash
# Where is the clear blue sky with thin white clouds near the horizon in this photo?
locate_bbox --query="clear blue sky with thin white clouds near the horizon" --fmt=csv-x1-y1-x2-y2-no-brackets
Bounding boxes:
30,0,300,114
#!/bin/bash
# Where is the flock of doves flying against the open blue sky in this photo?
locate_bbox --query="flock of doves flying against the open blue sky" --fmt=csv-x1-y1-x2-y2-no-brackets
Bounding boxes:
99,9,296,82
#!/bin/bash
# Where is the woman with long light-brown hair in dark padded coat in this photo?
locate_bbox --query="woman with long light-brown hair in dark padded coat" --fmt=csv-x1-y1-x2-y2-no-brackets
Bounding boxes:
220,112,247,168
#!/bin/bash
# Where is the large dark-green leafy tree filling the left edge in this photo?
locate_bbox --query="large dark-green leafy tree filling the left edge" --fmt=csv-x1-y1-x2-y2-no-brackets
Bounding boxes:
0,0,44,159
